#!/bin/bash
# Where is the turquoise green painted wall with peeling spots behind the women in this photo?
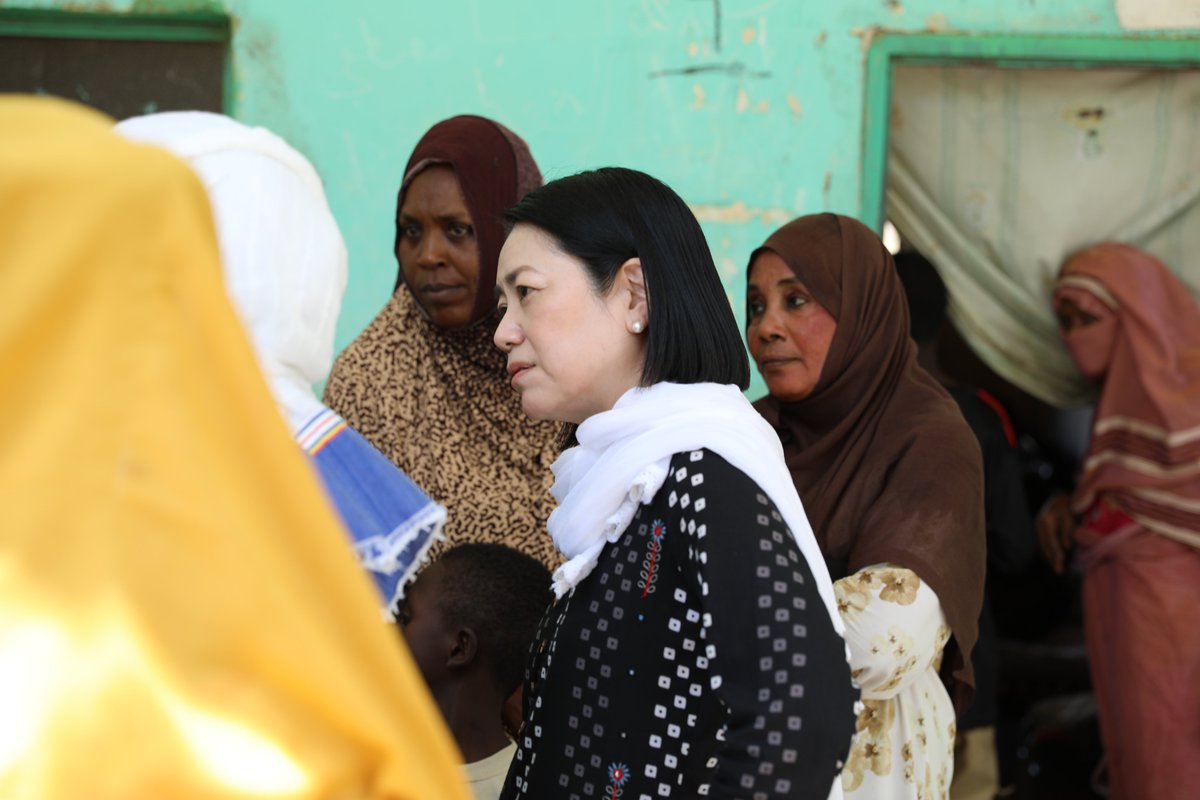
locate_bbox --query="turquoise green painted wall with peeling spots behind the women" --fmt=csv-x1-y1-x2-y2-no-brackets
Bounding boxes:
0,0,1180,396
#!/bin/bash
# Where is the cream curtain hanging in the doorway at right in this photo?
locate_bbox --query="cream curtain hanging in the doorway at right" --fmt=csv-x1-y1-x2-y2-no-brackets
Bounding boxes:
887,66,1200,405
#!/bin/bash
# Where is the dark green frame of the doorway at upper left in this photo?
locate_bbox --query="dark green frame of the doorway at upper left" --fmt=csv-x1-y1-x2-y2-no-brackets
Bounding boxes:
0,8,234,116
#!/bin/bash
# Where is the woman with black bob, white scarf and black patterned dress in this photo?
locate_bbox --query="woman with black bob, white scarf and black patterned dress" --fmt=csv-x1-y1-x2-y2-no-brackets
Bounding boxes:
496,168,858,799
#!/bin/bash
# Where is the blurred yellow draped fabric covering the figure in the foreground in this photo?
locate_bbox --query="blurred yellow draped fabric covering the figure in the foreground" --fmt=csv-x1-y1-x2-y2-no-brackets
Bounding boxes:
0,97,468,800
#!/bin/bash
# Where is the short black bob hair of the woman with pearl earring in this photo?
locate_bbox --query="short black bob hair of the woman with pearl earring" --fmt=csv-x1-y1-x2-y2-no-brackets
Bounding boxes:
504,167,750,390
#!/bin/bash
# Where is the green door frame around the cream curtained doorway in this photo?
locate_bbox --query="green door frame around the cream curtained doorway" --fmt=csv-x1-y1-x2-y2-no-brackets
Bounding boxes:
859,34,1200,231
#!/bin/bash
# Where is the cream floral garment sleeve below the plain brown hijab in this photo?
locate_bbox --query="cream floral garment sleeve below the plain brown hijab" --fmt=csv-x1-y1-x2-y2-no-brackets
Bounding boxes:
834,565,955,800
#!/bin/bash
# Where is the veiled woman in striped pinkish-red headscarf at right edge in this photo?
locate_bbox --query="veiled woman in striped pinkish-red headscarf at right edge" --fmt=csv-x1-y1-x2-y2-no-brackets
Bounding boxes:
1038,243,1200,800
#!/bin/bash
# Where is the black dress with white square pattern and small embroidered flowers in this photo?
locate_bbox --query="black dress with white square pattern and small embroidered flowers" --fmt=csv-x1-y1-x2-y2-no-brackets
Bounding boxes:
502,450,858,800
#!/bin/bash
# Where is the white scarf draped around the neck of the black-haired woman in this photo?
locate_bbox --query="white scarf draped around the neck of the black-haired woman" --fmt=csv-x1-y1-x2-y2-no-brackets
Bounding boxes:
547,383,844,633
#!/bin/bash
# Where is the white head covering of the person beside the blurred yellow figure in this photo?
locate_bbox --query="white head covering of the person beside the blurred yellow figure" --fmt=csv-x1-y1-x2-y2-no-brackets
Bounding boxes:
116,112,347,433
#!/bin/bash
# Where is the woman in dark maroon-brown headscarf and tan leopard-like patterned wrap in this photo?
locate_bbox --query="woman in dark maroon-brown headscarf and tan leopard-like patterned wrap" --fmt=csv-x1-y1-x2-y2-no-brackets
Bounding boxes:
325,116,558,567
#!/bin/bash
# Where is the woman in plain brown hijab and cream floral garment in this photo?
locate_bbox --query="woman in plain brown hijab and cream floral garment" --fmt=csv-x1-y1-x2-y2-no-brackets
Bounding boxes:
746,213,984,799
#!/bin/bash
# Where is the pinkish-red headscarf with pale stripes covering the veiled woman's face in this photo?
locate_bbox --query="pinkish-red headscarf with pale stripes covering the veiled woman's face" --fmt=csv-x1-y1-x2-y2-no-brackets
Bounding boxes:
1055,242,1200,547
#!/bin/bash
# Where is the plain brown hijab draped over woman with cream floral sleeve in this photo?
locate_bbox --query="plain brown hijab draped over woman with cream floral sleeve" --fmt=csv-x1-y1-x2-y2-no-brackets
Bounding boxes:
750,213,984,710
